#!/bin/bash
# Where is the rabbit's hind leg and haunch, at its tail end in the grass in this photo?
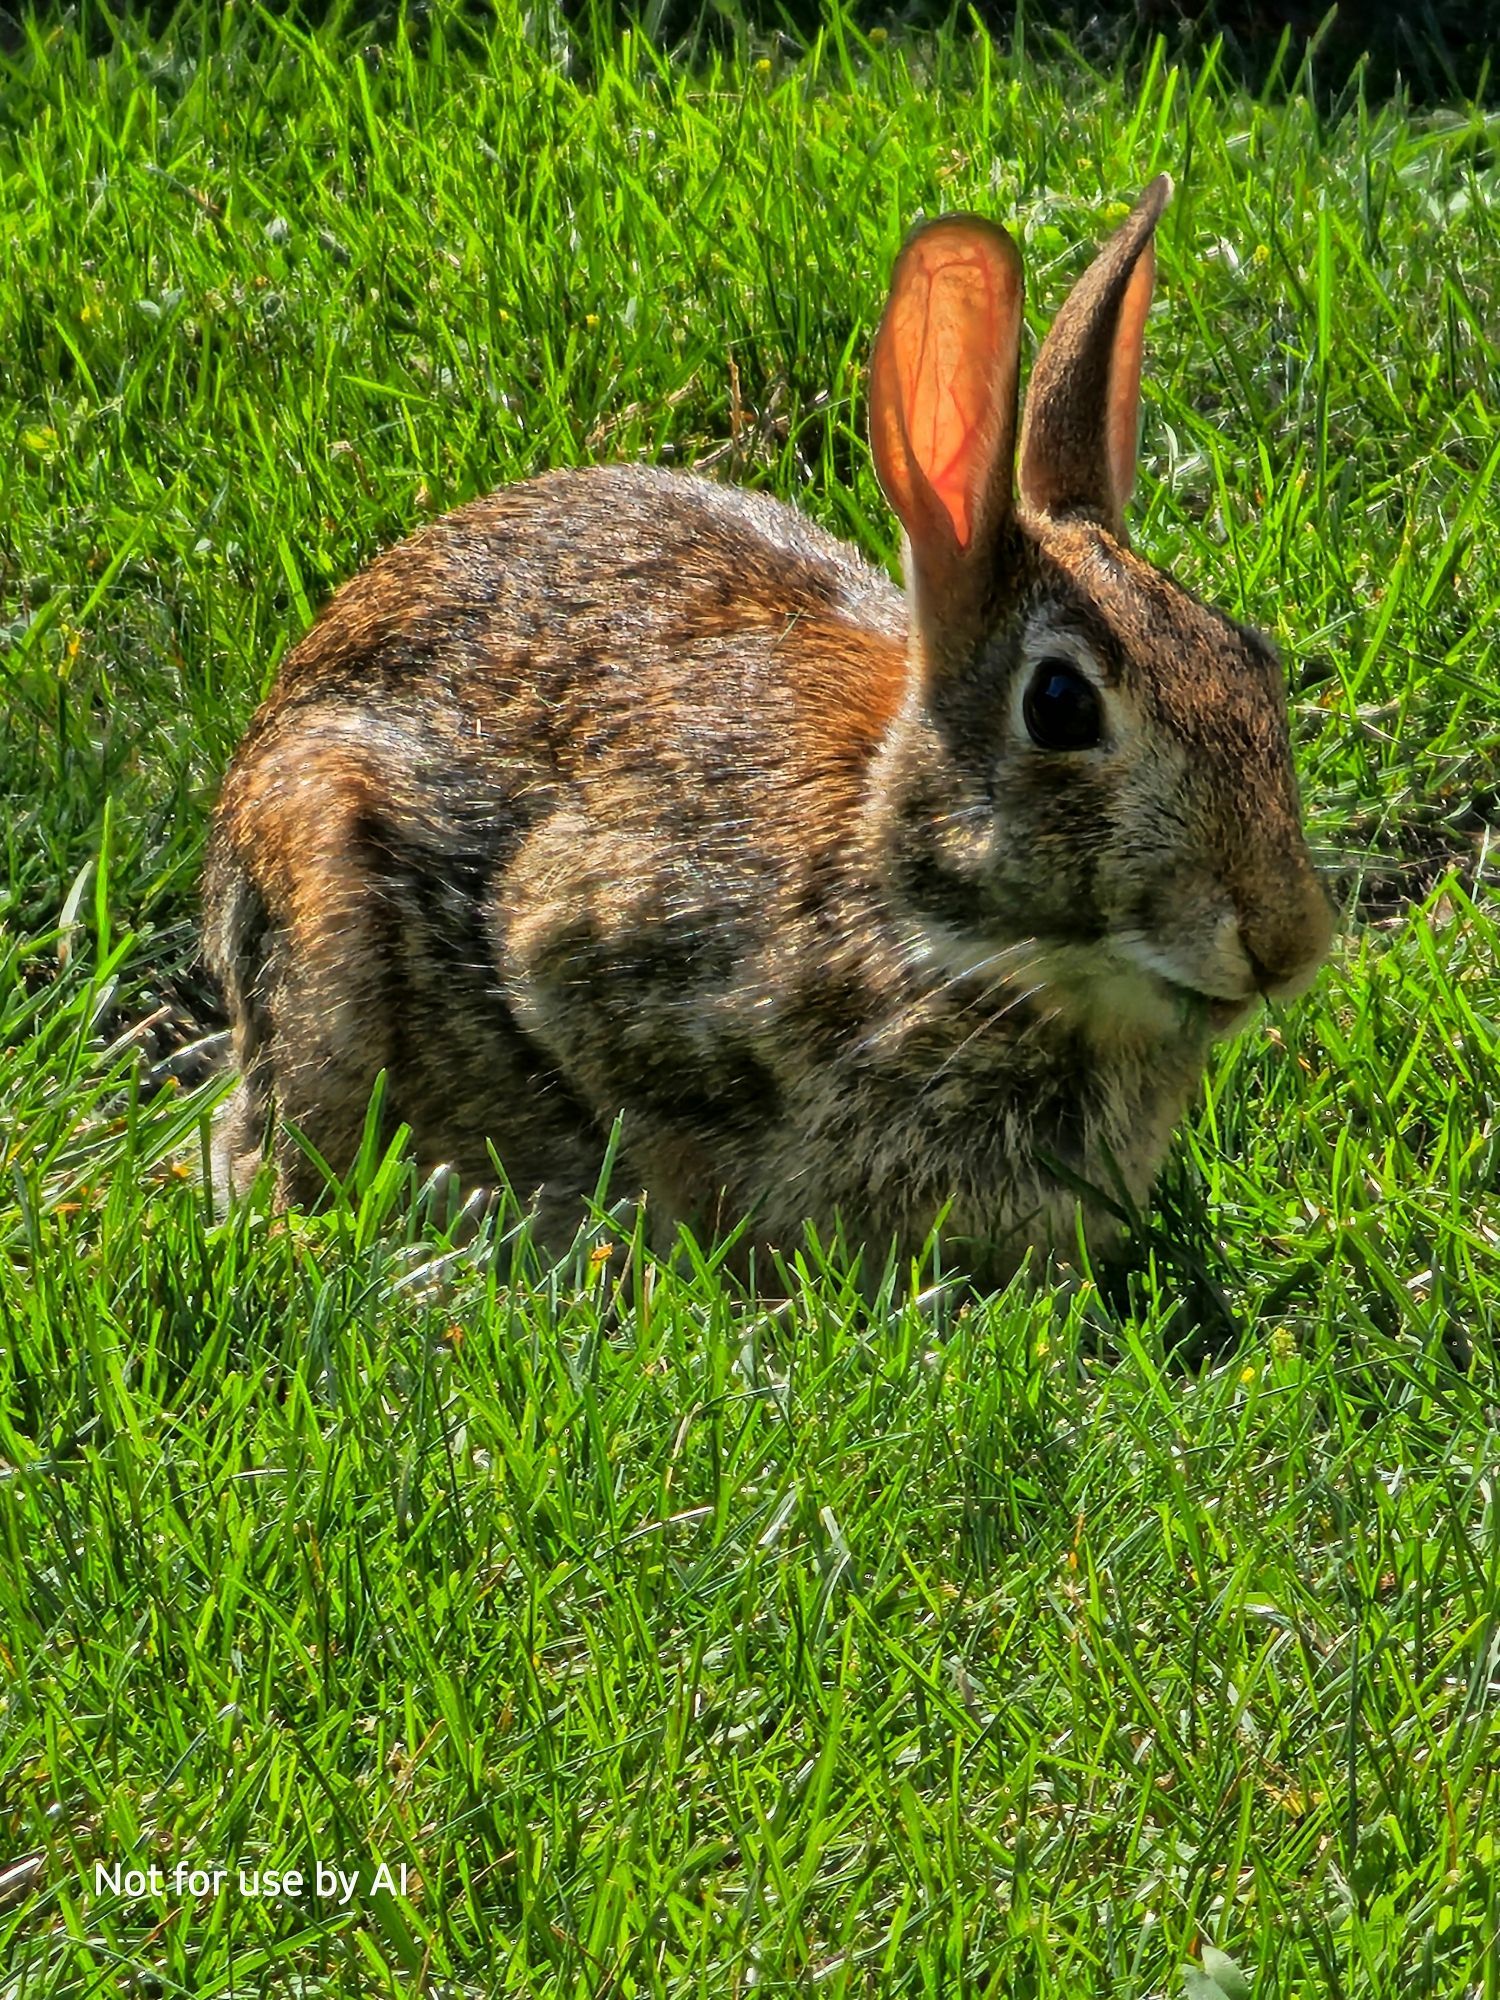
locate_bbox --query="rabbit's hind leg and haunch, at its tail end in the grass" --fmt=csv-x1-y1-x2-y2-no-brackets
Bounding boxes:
204,710,628,1242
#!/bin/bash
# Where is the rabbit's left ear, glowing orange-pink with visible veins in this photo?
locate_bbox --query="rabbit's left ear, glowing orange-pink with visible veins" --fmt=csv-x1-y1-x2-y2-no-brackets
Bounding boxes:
870,216,1022,624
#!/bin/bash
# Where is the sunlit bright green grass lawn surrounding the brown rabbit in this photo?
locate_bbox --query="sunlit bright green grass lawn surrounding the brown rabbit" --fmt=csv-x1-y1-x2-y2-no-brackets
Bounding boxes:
0,0,1500,2000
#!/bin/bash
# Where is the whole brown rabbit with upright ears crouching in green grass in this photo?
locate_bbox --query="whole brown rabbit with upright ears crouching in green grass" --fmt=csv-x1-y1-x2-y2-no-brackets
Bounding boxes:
204,176,1330,1278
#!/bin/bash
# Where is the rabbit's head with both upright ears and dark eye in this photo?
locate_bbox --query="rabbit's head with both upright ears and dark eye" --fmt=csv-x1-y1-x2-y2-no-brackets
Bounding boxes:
870,176,1332,1040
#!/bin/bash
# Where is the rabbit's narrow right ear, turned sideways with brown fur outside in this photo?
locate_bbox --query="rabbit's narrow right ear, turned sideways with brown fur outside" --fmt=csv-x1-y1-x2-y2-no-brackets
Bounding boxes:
1020,174,1172,542
